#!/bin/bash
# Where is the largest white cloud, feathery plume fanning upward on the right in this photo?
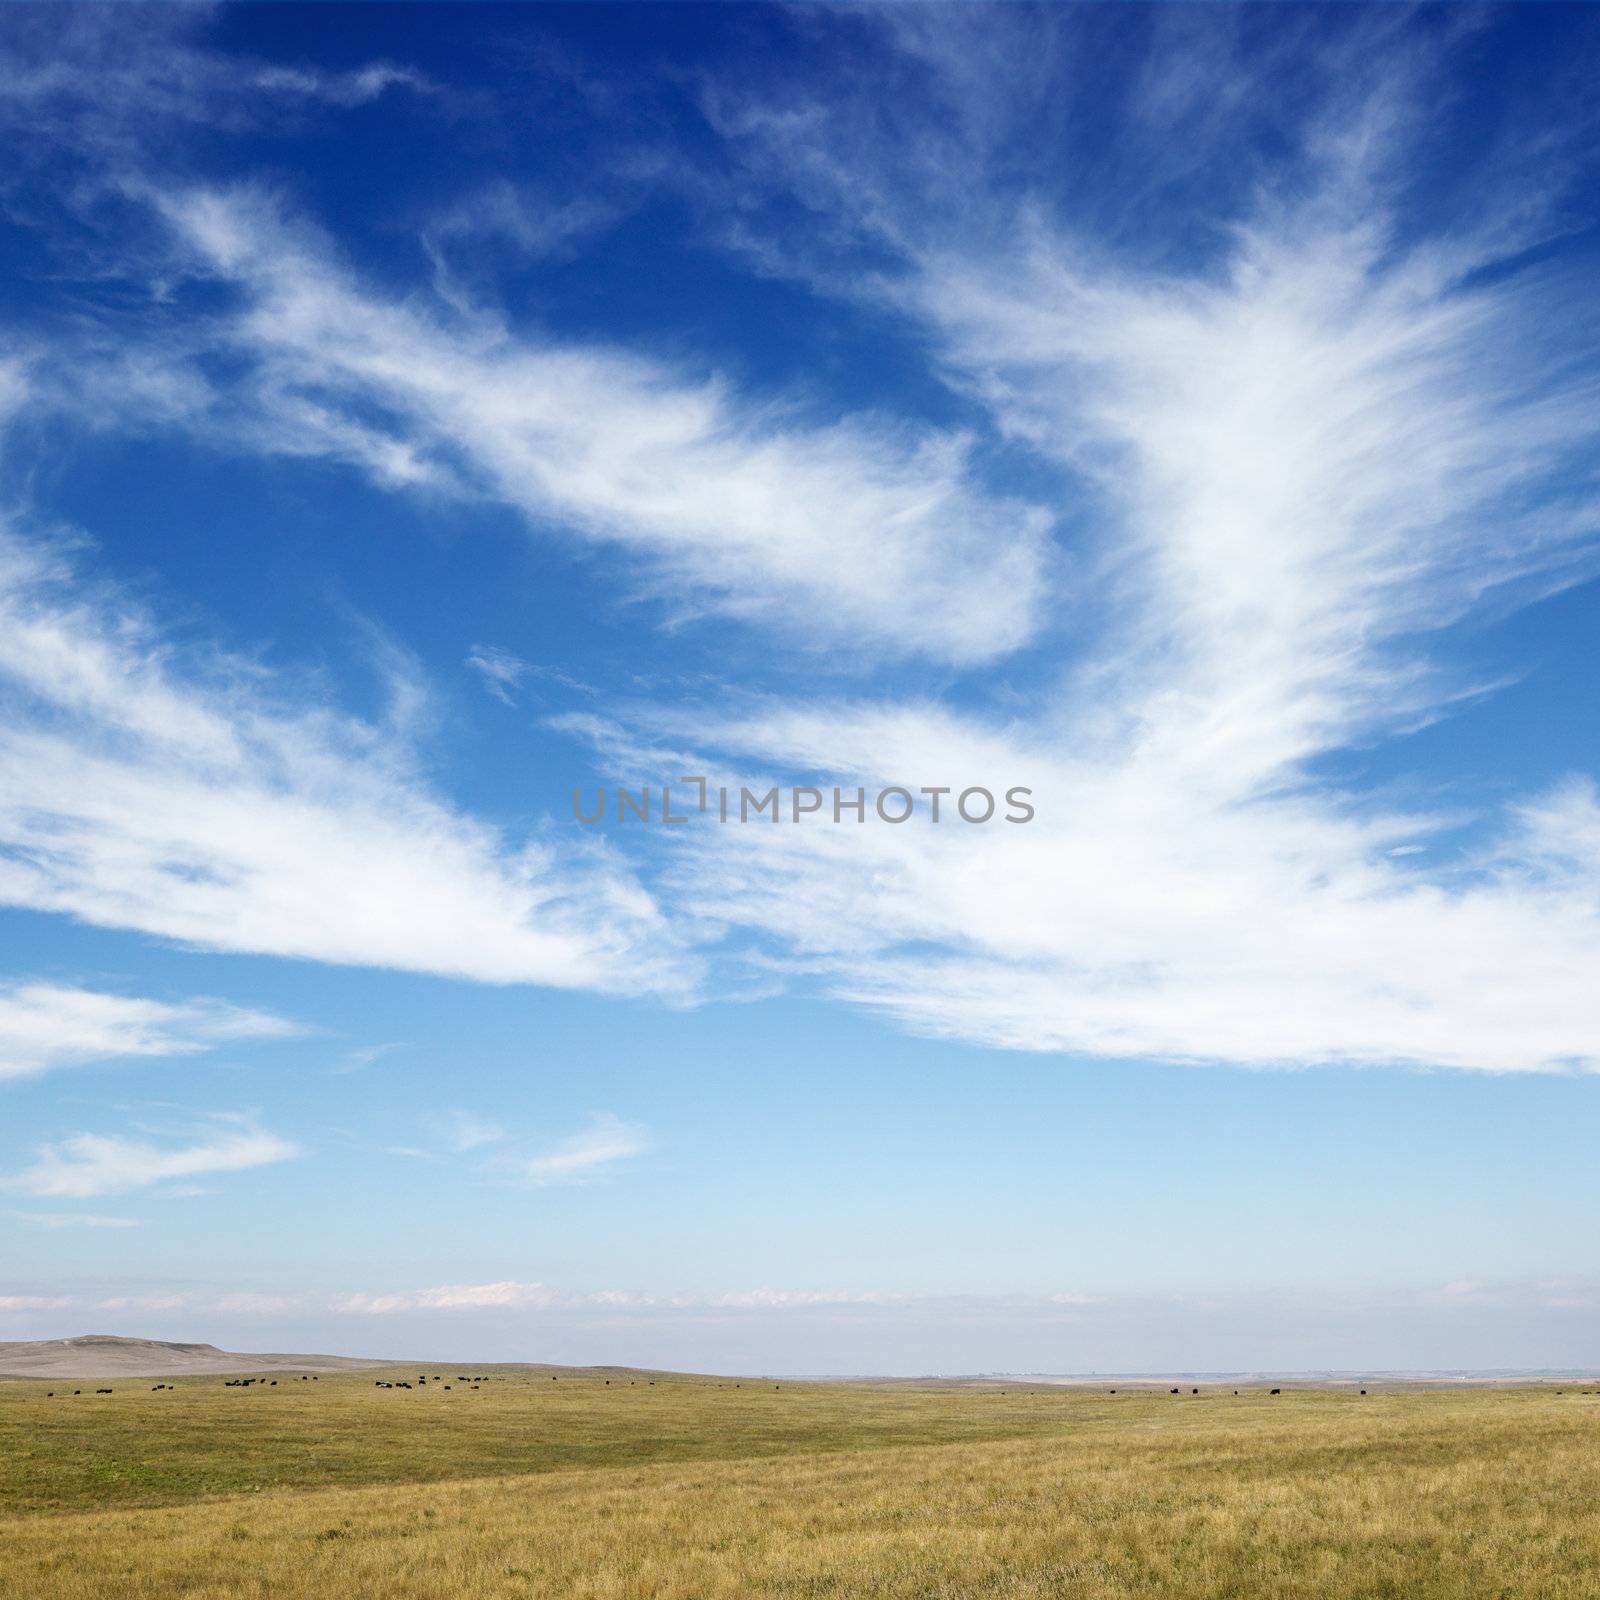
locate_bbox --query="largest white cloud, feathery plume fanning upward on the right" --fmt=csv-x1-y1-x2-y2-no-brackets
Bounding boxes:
627,43,1600,1070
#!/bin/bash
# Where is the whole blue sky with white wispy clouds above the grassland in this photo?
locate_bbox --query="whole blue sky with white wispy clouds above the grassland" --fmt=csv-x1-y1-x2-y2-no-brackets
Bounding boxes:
0,5,1600,1371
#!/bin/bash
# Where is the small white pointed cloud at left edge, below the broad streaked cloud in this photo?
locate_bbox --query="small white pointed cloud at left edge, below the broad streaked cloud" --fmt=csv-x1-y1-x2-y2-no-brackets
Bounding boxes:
0,982,296,1078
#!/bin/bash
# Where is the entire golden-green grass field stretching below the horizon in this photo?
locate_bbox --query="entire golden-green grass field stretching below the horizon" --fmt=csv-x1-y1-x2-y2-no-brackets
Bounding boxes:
0,1365,1600,1600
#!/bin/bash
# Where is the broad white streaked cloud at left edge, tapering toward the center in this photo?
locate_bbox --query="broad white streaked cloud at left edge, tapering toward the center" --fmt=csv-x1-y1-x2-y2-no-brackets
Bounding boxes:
0,533,691,994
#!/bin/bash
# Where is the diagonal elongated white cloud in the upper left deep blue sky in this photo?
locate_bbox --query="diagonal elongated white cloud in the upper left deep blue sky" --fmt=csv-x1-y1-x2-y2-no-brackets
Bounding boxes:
157,190,1045,661
